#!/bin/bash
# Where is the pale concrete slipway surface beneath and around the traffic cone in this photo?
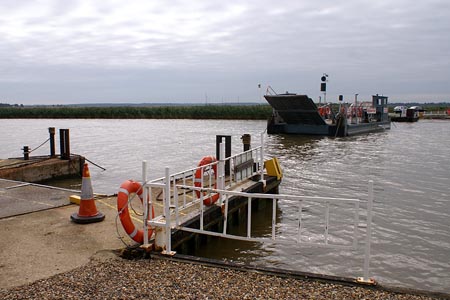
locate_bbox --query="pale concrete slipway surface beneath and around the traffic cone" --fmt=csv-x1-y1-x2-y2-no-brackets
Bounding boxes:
0,180,130,288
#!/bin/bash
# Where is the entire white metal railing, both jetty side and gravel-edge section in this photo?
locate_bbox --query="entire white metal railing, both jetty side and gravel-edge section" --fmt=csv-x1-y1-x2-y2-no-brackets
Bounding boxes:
142,135,373,283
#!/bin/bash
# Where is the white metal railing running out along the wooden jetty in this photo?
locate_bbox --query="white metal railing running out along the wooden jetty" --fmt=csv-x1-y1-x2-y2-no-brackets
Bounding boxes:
142,133,265,253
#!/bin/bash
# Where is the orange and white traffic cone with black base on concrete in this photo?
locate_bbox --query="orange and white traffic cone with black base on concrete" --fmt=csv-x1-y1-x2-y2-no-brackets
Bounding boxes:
70,163,105,224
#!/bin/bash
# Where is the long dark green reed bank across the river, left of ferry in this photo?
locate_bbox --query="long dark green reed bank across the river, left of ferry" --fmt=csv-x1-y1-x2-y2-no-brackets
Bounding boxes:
0,105,272,120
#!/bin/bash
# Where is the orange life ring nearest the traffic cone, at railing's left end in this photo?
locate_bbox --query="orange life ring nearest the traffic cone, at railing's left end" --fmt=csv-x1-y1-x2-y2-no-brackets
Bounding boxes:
117,180,155,244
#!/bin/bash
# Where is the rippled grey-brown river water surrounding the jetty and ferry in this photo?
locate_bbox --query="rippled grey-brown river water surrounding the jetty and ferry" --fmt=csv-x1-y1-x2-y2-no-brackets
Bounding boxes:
0,119,450,293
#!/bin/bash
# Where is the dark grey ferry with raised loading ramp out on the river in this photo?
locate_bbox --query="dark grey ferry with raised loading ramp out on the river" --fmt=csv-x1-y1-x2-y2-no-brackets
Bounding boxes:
264,93,391,137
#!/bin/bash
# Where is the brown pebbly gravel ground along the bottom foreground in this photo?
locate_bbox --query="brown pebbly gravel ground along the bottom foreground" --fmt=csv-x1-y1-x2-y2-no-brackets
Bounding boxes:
0,255,442,300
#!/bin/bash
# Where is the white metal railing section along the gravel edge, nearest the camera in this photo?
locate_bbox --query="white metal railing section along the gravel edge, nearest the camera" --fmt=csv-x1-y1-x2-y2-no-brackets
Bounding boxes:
144,164,374,283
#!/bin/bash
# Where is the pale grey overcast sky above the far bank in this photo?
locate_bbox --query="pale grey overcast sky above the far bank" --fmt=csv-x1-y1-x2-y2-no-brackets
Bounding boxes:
0,0,450,105
